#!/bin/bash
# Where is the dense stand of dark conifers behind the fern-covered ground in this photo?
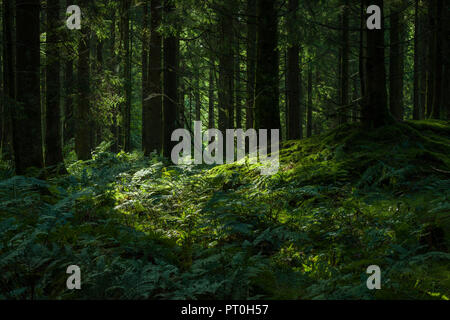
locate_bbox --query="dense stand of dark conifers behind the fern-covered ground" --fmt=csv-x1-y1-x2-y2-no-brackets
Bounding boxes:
1,0,450,173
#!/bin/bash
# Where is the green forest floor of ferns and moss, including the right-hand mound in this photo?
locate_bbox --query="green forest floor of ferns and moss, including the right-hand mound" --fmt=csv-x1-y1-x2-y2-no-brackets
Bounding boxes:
0,121,450,299
